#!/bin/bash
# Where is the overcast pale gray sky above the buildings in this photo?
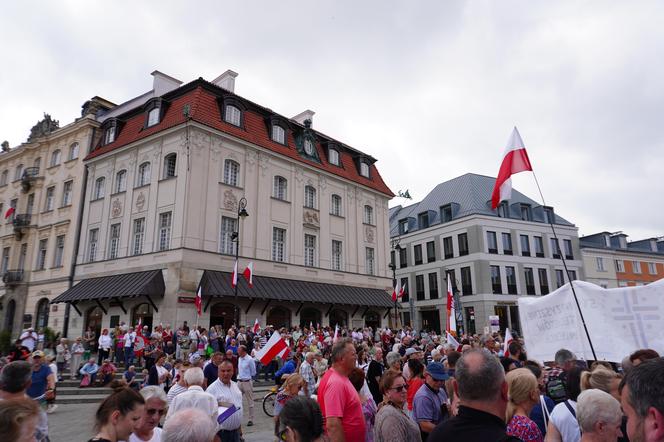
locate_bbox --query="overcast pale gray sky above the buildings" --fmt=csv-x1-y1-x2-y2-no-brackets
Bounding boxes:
0,0,664,240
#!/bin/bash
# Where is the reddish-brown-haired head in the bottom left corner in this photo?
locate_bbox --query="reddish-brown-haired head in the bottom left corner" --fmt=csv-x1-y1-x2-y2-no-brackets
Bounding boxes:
0,398,40,442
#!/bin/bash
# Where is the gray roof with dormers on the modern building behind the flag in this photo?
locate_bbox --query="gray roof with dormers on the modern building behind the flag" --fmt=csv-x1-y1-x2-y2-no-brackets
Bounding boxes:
389,173,573,236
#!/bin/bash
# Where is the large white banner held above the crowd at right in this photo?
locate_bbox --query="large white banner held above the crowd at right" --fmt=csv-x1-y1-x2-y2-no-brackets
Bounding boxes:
519,279,664,362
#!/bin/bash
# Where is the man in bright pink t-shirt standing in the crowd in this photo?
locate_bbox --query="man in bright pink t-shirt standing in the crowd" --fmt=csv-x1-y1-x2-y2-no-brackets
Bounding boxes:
318,338,365,442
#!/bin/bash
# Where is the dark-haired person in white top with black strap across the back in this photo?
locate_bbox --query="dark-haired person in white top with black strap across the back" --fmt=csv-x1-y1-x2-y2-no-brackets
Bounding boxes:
546,366,585,442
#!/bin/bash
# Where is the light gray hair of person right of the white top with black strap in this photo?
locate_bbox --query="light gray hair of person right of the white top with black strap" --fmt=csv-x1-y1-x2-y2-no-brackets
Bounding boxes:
576,389,622,433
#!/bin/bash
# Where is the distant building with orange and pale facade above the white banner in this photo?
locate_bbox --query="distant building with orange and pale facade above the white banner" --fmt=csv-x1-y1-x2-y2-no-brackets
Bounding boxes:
579,232,664,288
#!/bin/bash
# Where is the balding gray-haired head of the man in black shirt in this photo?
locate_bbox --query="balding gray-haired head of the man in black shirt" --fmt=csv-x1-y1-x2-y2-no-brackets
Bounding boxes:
455,349,505,401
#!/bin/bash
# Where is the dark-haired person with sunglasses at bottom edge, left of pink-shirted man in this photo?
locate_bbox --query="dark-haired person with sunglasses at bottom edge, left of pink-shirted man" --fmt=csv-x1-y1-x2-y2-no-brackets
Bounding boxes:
277,397,325,442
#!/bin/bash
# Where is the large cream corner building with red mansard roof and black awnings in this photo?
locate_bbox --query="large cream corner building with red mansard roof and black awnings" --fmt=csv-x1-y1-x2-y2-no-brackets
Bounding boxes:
55,71,393,334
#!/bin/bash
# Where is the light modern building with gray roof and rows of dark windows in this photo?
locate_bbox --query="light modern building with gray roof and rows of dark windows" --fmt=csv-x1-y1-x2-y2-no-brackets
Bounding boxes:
389,173,583,333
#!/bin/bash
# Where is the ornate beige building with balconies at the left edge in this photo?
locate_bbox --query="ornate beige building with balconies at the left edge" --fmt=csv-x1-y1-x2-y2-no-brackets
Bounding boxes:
0,97,111,337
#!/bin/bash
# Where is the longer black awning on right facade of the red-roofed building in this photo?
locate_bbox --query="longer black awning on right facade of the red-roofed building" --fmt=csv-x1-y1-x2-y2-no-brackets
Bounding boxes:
201,270,394,308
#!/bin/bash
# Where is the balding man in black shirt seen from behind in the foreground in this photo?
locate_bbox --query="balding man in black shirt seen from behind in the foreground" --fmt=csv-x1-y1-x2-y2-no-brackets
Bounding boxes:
429,349,519,442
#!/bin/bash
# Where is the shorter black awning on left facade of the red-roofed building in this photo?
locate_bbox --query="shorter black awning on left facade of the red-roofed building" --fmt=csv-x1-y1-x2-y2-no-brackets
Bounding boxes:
51,270,165,304
